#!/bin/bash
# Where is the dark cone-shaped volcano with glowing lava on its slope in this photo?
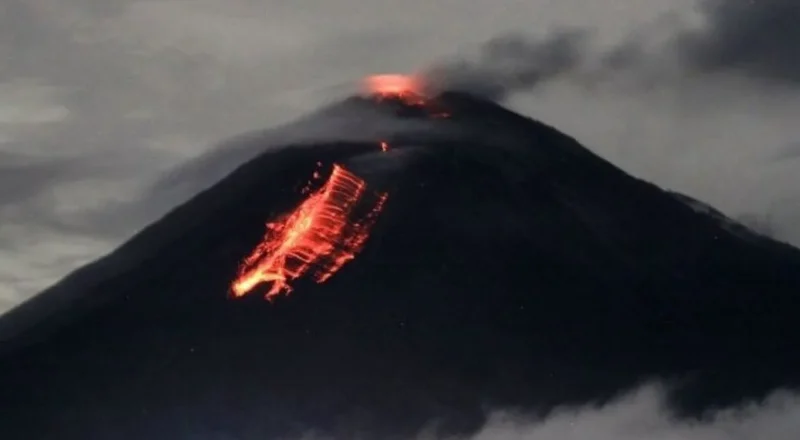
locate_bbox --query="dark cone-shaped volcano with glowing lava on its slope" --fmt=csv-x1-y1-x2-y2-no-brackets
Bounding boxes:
0,92,800,440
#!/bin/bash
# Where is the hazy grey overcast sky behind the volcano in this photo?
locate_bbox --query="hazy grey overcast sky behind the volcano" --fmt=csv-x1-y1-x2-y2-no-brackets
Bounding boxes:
0,0,800,310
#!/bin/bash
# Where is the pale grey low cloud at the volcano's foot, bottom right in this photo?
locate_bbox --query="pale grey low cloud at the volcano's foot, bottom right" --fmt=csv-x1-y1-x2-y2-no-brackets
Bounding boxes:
440,387,800,440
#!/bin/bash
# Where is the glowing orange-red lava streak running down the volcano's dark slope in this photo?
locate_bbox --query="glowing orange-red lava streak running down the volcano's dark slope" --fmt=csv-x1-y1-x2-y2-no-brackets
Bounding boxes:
231,165,388,300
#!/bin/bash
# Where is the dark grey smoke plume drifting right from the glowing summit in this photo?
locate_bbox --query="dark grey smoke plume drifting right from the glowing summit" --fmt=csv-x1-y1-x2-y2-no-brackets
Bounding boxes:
426,0,800,101
